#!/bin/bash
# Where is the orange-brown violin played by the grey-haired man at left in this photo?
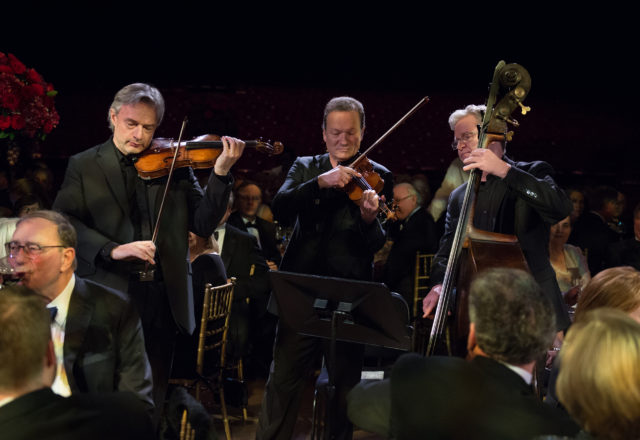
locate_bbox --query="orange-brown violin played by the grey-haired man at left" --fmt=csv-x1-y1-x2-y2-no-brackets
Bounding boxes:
134,134,284,180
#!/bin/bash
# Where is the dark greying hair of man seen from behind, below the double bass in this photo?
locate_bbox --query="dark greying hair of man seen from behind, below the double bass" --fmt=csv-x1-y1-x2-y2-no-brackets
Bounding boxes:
469,268,556,365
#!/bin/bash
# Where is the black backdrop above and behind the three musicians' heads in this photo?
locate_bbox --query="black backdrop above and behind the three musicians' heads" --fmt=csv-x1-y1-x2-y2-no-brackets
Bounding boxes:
0,9,640,218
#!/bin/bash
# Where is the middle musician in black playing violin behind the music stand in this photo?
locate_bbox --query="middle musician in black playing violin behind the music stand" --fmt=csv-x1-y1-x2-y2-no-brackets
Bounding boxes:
256,97,393,439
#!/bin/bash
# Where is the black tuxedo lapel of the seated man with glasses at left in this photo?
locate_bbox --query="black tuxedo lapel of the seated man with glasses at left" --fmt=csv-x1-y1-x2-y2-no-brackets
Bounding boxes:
64,277,93,393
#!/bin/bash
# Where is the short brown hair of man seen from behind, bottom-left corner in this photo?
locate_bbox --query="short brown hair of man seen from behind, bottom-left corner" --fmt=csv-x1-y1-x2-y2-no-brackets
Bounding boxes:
0,285,51,391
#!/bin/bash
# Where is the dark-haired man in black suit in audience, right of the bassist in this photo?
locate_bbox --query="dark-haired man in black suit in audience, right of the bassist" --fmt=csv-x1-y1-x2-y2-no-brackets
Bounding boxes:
569,186,618,273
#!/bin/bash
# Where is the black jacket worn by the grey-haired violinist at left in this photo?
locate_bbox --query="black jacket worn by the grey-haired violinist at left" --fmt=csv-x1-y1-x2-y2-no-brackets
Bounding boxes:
53,139,232,333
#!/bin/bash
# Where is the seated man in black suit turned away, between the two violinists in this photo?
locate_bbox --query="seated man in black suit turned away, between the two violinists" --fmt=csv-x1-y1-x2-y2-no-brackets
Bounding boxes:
214,194,275,375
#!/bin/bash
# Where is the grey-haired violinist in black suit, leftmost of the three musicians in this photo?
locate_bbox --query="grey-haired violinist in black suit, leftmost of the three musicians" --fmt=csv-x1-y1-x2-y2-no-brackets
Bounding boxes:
53,83,244,420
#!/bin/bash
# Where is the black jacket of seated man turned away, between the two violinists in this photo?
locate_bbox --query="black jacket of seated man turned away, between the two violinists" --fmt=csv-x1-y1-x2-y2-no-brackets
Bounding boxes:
220,223,270,301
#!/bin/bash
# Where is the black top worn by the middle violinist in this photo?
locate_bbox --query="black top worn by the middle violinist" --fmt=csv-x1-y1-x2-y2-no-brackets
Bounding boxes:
272,154,393,281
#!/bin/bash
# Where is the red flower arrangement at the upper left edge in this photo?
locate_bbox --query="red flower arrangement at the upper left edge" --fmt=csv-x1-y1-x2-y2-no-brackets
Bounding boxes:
0,52,60,140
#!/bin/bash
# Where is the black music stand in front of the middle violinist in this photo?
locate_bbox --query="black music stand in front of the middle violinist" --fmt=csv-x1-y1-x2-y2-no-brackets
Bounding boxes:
270,271,411,438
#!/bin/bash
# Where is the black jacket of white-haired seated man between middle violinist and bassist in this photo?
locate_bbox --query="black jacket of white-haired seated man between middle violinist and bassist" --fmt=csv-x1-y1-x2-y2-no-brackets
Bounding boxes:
382,207,438,304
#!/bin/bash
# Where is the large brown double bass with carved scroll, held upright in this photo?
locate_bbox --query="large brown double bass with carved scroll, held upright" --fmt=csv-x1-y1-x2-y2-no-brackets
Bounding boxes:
424,61,531,357
